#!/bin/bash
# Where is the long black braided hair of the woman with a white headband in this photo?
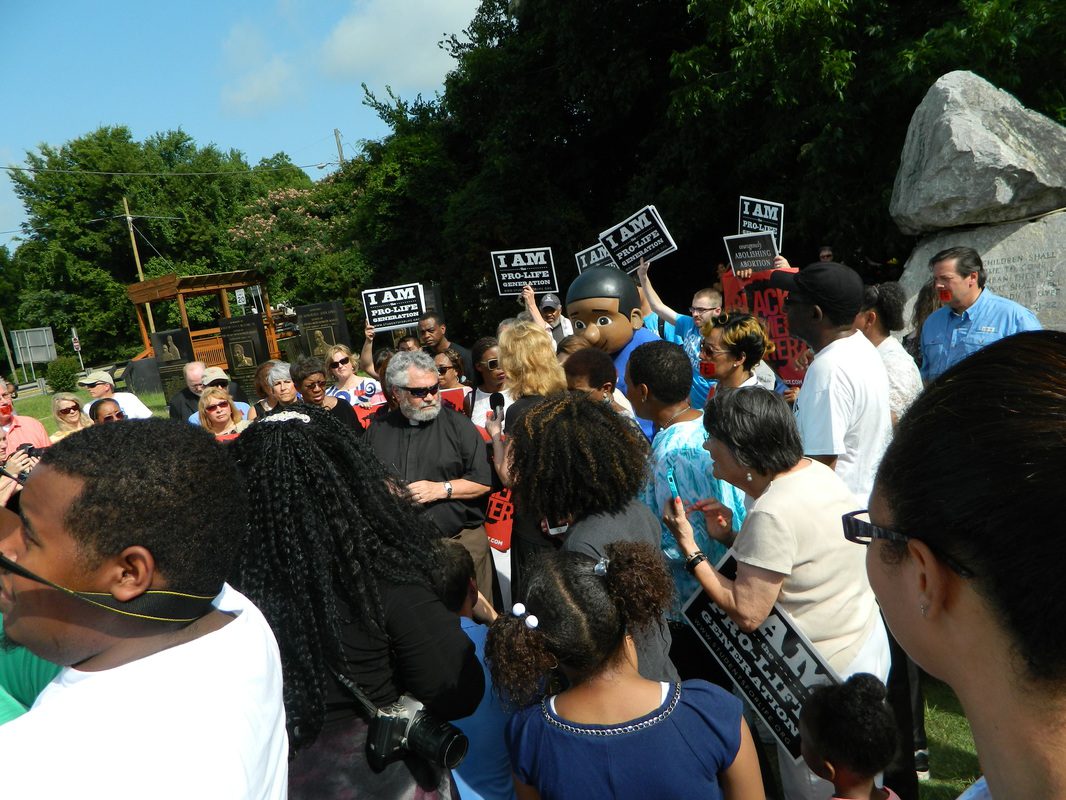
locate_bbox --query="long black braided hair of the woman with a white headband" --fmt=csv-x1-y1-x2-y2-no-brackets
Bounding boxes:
229,404,441,750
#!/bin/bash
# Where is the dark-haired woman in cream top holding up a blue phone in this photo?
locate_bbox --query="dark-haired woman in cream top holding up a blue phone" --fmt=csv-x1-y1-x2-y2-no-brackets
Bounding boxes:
663,386,890,798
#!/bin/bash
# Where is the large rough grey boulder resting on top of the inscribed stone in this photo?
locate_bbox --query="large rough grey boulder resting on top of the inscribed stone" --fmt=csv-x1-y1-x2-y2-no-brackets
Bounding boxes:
889,71,1066,234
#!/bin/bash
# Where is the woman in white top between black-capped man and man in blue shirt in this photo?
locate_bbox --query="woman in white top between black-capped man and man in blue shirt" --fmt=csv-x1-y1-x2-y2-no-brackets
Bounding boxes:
855,283,922,427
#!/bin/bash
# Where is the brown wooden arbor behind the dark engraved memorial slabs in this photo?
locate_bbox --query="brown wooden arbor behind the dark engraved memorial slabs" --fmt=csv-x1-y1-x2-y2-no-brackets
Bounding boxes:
126,270,278,368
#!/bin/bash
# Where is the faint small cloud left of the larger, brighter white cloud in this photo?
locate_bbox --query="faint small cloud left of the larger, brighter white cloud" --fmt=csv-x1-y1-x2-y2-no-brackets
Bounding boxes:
221,23,300,116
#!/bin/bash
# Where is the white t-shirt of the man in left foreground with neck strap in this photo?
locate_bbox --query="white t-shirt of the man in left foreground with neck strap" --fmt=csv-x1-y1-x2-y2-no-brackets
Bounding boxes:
0,586,289,800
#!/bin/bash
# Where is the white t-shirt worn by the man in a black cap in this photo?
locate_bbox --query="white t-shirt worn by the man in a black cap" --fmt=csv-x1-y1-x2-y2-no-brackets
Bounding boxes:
795,331,892,508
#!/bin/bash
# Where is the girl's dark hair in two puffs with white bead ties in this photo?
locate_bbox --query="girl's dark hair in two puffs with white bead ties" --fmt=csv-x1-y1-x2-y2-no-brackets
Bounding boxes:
485,542,674,705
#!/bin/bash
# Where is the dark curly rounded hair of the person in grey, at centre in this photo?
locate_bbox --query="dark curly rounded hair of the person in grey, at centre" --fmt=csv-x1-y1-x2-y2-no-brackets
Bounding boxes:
507,391,648,521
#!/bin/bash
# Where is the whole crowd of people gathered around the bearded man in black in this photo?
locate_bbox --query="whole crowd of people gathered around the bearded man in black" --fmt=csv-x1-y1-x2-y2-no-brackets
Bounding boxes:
0,247,1048,800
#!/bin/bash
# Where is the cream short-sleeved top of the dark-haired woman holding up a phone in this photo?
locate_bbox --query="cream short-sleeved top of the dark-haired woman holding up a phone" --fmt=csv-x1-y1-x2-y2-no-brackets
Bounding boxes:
732,460,881,672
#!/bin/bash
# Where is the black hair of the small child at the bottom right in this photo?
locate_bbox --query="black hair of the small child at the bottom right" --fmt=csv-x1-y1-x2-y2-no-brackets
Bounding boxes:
800,672,898,778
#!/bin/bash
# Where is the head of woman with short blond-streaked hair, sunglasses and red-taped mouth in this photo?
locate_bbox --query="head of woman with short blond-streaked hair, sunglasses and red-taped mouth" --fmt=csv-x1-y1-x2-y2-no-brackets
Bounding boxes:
699,313,774,392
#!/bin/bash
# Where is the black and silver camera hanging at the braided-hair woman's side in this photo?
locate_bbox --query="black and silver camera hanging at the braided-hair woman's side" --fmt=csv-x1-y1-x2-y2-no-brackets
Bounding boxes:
367,694,470,772
